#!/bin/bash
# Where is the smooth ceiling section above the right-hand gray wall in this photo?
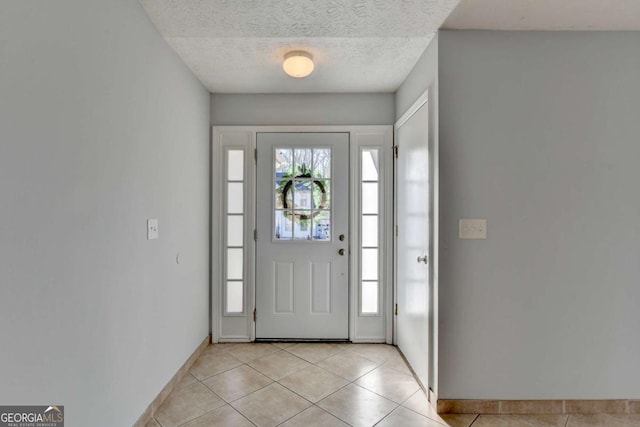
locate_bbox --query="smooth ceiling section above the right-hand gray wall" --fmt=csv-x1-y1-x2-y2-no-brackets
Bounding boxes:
443,0,640,31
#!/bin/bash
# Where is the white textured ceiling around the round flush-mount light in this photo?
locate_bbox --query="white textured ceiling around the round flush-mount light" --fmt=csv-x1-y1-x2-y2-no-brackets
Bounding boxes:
140,0,459,93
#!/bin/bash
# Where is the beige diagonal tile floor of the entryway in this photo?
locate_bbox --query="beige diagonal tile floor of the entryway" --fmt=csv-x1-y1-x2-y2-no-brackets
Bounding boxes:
147,343,640,427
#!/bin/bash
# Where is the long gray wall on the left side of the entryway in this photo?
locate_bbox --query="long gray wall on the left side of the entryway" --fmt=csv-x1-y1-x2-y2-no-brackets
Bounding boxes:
0,0,210,426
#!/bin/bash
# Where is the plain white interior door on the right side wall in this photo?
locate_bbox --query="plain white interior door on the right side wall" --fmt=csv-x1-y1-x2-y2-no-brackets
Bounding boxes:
396,104,431,387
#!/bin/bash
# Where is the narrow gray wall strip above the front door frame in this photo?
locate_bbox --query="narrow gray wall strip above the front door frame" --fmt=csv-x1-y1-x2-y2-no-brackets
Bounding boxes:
211,93,394,126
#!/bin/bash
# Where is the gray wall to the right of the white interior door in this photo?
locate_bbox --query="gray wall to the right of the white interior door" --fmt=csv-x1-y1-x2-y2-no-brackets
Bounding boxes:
439,31,640,399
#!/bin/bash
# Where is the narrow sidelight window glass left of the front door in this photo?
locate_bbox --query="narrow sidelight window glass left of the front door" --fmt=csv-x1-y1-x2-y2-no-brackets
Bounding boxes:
224,148,245,316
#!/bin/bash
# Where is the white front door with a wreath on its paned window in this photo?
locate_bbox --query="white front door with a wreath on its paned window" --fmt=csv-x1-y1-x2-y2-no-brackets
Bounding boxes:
256,133,349,339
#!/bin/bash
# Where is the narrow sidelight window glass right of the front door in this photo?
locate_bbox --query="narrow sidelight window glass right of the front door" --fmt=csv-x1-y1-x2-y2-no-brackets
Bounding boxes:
360,148,381,315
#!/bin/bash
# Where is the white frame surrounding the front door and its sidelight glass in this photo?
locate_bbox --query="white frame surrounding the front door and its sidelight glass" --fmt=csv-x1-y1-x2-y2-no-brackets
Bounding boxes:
210,125,394,344
